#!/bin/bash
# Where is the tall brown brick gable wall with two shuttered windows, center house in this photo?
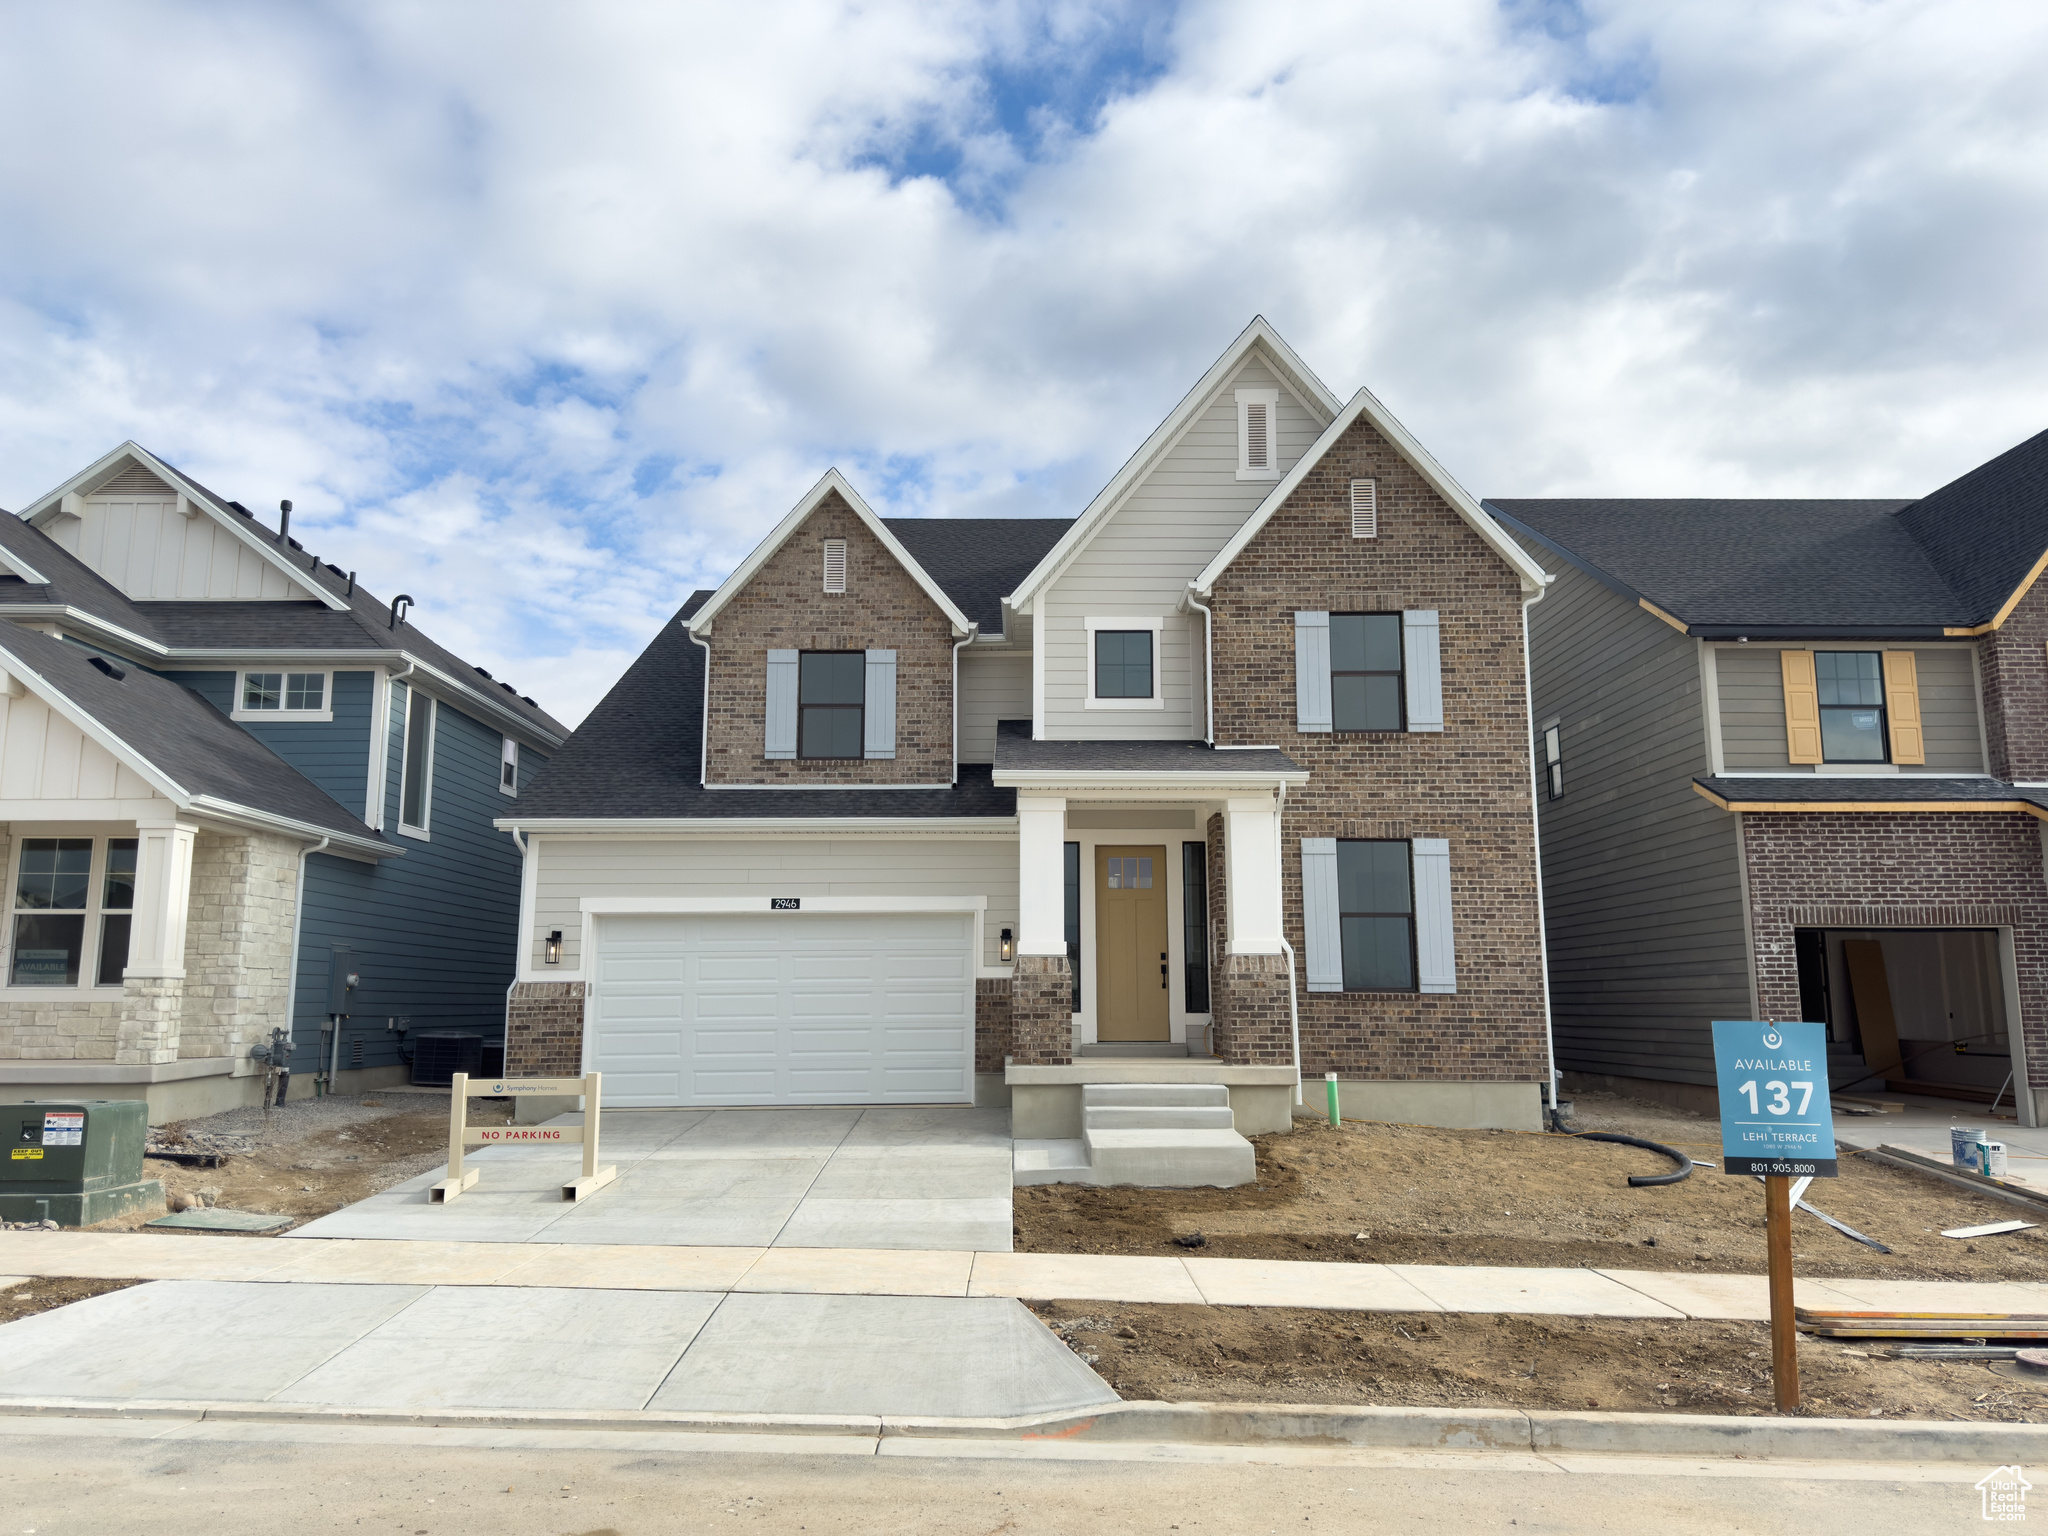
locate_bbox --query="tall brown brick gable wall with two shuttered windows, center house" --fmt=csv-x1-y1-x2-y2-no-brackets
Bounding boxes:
1210,409,1548,1083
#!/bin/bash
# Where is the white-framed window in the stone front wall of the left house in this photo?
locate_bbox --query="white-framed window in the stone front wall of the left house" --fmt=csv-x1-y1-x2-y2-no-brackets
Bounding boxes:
8,838,137,987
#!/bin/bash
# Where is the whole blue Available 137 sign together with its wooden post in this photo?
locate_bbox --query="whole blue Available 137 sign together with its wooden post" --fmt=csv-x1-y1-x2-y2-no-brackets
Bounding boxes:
1714,1020,1835,1413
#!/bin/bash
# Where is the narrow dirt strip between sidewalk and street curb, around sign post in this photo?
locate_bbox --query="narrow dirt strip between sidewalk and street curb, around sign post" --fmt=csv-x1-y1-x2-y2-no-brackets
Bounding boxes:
1032,1303,2048,1423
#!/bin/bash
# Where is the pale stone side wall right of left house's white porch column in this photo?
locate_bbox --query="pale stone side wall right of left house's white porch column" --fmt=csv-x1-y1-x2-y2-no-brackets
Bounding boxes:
181,831,305,1059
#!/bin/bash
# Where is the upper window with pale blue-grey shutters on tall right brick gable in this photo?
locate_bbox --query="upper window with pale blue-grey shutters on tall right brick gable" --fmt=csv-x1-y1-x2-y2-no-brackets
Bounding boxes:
1294,608,1444,733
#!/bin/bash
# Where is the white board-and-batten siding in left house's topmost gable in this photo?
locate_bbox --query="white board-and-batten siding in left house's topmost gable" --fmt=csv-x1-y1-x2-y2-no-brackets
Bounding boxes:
45,469,307,602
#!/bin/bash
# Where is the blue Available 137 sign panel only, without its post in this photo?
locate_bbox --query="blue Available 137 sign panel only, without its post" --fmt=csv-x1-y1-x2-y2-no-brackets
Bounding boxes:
1714,1022,1835,1178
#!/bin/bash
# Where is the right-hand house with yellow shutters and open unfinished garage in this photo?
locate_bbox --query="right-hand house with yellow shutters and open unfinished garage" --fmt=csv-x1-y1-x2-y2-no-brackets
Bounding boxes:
1487,434,2048,1124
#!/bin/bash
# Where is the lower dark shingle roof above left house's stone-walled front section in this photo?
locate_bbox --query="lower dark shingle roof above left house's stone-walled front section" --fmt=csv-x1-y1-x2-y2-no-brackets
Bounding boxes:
0,625,397,852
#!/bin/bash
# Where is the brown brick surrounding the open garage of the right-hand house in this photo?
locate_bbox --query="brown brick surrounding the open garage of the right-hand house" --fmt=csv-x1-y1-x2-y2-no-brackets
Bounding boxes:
1743,811,2048,1092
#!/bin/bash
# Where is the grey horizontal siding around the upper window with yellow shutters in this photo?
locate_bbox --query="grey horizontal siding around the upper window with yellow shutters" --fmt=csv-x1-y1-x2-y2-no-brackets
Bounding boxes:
1714,641,1985,774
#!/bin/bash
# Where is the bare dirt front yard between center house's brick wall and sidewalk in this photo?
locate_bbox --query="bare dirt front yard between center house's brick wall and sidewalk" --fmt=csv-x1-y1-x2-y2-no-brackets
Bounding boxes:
1014,1096,2048,1280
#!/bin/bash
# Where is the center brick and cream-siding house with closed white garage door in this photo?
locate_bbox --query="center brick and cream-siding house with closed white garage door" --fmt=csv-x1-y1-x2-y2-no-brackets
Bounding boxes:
500,319,1550,1137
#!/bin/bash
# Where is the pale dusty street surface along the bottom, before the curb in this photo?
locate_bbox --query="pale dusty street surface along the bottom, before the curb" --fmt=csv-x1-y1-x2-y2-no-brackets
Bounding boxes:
0,1419,1991,1536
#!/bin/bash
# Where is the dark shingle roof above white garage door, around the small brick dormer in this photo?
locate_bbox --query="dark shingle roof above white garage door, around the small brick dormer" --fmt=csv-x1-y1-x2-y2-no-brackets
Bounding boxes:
508,592,1016,821
